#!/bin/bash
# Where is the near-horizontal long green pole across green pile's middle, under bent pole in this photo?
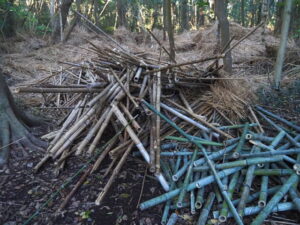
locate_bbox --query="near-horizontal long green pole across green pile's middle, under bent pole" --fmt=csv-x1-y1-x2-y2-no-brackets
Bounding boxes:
193,156,283,172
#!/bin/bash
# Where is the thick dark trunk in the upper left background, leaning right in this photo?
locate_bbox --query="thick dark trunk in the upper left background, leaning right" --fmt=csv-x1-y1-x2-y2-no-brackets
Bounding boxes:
52,0,73,43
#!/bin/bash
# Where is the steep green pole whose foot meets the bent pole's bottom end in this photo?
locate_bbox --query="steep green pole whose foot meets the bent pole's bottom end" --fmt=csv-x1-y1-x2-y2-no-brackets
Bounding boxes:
237,146,260,218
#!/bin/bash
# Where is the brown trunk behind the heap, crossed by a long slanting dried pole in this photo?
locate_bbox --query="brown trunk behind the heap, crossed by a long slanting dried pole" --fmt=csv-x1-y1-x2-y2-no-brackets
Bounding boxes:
215,0,232,74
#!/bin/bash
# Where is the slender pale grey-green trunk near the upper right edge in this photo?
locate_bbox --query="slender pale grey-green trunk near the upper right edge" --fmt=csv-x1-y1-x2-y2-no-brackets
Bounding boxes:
274,0,293,90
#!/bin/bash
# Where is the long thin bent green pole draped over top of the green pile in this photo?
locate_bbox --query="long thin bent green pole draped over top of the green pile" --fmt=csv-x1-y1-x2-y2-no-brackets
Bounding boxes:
142,100,243,225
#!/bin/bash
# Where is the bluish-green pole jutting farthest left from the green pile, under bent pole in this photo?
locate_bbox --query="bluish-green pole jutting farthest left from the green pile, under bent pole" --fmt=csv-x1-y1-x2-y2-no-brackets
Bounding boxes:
140,167,242,210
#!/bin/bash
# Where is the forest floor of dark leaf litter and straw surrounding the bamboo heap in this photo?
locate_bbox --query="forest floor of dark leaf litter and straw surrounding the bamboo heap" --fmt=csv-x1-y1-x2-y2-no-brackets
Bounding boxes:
0,23,300,225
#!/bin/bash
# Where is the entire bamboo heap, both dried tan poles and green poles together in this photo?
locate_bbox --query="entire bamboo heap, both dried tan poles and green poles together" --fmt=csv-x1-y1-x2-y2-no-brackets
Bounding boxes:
16,40,300,224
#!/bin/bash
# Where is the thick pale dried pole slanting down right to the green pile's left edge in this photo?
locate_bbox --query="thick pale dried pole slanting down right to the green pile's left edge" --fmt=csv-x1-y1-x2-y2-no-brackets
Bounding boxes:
112,103,169,191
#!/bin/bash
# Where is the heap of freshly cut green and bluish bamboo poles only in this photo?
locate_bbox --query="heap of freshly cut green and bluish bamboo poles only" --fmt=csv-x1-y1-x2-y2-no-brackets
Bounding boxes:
140,102,300,225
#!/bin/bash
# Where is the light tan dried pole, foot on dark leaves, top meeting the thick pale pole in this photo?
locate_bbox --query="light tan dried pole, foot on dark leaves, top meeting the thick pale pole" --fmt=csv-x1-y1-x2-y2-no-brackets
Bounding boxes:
95,143,134,205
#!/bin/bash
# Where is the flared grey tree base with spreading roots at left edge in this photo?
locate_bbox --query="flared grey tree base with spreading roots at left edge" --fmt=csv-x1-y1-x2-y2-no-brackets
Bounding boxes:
0,72,46,171
